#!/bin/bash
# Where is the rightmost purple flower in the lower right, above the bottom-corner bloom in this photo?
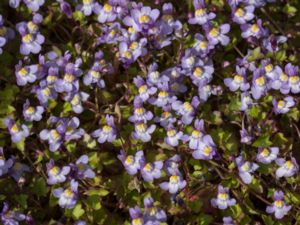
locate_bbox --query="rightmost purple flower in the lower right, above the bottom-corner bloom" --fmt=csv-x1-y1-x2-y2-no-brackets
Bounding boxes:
275,157,299,178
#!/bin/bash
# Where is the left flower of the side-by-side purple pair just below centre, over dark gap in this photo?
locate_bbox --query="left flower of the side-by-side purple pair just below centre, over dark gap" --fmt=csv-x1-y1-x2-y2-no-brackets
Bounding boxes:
118,150,145,175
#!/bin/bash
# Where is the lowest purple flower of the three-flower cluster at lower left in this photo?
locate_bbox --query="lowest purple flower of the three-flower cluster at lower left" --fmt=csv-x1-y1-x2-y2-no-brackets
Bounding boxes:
52,180,78,209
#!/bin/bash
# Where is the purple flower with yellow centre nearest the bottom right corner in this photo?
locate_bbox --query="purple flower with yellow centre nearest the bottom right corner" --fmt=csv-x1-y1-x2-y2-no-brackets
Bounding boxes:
266,191,292,219
